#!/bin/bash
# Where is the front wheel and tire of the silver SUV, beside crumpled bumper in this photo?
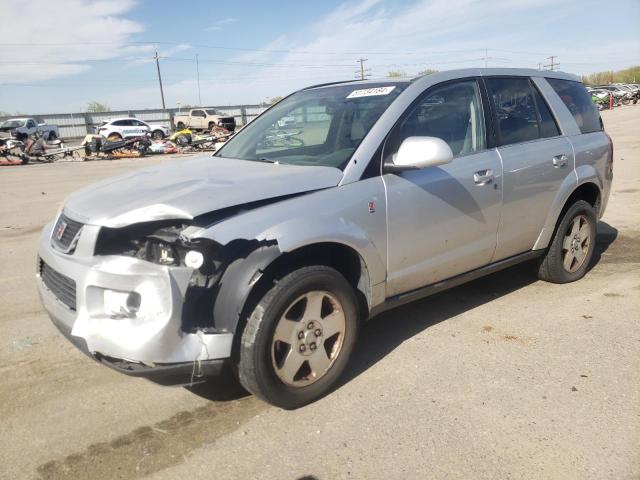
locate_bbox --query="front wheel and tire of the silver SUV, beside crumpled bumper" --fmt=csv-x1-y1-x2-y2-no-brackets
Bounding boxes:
238,266,358,409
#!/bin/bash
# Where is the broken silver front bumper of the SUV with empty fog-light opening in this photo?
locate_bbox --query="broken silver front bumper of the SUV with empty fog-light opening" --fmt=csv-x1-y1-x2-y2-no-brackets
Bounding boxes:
37,223,233,385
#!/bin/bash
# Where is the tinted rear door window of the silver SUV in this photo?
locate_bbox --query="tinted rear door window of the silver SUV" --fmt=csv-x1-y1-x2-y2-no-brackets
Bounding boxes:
487,78,560,145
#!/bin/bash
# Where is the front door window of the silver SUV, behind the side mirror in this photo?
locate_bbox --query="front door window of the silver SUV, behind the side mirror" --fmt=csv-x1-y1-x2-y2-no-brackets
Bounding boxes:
388,80,486,156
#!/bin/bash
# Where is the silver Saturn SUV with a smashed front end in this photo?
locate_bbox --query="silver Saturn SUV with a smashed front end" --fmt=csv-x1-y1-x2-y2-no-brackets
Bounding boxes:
37,69,613,408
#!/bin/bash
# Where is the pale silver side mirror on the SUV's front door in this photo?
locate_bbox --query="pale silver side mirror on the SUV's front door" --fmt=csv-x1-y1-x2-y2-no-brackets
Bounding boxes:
385,137,453,173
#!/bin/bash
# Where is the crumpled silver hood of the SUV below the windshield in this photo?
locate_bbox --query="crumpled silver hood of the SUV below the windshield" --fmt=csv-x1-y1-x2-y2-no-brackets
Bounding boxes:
64,156,342,228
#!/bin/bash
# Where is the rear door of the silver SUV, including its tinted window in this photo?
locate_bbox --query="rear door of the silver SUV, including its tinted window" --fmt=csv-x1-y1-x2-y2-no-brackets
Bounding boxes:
485,77,574,261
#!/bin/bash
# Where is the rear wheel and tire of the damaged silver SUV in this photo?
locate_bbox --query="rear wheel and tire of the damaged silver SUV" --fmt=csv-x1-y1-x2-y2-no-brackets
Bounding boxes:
538,200,598,283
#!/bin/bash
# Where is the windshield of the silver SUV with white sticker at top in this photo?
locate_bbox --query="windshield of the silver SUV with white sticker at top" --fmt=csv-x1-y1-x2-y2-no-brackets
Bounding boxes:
216,83,406,169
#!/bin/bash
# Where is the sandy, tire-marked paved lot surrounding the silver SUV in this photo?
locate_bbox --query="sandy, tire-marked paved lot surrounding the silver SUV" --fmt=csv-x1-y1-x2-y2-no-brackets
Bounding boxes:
0,106,640,480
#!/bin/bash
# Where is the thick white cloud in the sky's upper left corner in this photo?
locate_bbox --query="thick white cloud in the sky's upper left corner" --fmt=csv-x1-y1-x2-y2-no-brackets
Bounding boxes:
0,0,143,84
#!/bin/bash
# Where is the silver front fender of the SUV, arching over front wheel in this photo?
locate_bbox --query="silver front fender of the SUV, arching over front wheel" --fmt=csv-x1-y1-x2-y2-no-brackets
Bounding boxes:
193,177,387,329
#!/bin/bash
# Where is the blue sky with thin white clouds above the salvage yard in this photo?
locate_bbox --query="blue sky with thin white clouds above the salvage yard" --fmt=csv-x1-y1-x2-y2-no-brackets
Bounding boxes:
0,0,640,113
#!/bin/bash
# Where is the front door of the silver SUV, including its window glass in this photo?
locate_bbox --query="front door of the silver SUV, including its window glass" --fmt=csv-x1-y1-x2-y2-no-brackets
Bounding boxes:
383,79,502,297
